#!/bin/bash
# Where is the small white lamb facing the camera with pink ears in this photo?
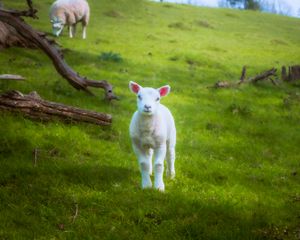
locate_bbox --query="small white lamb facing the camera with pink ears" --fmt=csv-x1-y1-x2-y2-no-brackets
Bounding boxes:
129,82,176,191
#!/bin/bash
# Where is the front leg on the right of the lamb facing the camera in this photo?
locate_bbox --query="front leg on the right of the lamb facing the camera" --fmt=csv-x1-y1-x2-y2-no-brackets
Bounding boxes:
154,144,167,191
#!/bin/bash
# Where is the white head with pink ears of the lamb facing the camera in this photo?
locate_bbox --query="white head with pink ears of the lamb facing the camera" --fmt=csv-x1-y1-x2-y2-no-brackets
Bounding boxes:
129,81,171,115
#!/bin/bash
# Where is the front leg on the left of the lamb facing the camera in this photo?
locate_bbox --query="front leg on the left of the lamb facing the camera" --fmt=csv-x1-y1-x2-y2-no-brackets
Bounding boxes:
132,143,152,189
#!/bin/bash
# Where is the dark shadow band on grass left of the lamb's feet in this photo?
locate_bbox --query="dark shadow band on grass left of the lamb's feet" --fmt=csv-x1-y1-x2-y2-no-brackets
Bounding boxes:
0,162,134,191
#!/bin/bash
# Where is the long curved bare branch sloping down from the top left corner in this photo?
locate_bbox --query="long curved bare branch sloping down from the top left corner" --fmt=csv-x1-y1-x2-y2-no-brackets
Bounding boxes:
0,0,118,100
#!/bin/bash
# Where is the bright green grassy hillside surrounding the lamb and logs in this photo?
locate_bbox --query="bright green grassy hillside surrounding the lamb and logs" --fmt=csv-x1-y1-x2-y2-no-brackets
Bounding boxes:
0,0,300,240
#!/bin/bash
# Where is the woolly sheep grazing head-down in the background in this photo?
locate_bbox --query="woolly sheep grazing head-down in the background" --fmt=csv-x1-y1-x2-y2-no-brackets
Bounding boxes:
50,0,90,39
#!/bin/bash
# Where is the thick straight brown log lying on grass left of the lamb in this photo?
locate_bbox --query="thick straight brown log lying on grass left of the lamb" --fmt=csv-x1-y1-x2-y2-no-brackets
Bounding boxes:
0,91,112,126
